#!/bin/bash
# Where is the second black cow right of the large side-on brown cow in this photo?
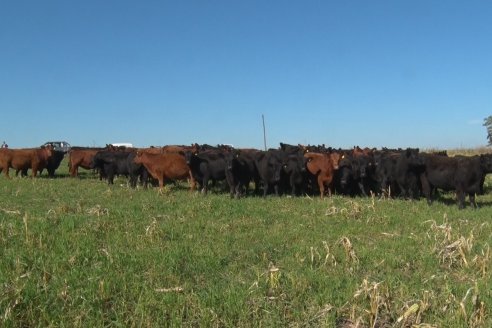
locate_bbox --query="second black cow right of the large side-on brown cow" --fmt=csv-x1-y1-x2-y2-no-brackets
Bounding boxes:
225,149,259,198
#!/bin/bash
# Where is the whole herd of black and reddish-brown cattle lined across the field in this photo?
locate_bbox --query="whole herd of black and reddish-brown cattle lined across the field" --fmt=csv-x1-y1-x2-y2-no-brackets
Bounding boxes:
0,143,492,208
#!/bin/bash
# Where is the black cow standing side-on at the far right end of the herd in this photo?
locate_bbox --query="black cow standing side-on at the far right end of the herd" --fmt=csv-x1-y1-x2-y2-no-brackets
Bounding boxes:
420,155,492,209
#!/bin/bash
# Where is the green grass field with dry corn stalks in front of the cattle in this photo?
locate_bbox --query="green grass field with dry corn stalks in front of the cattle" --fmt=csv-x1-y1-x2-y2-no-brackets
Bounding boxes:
0,158,492,327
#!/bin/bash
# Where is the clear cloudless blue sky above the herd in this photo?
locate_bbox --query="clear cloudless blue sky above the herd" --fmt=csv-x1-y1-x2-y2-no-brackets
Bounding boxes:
0,0,492,149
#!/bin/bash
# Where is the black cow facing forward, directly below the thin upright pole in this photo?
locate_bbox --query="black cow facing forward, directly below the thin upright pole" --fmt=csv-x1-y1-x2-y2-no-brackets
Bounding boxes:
255,149,286,196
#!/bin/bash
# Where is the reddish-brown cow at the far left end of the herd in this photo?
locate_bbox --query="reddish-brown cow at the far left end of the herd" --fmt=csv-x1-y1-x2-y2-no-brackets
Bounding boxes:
0,146,53,179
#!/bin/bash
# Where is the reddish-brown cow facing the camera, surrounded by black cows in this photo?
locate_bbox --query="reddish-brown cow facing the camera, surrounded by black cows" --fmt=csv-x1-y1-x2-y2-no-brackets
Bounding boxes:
304,152,342,198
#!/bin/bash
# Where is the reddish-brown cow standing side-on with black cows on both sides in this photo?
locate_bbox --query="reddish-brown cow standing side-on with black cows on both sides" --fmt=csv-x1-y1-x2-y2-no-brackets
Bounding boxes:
134,151,195,191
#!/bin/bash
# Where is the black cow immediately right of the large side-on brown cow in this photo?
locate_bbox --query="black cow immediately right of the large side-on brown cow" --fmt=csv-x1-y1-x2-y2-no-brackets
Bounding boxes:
185,149,226,194
